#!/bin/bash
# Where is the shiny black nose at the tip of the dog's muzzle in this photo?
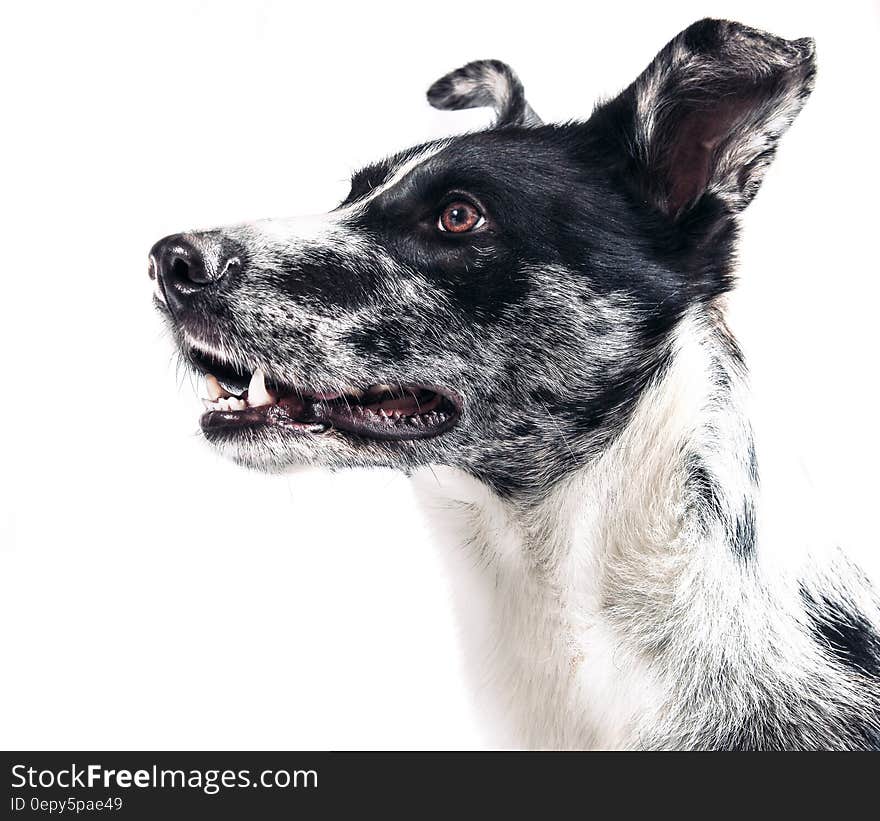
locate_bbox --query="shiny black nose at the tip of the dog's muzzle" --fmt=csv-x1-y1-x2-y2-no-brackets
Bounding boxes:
150,233,240,312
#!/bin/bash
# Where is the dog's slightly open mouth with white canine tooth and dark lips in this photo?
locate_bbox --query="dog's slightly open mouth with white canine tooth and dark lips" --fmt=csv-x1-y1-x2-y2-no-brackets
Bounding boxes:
189,351,461,440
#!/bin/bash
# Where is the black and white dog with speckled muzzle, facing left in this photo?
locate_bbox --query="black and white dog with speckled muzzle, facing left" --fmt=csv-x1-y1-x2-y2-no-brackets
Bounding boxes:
150,20,880,749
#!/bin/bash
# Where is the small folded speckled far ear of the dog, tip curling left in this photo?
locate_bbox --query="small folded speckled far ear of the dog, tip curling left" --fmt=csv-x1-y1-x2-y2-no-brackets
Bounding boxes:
428,60,541,128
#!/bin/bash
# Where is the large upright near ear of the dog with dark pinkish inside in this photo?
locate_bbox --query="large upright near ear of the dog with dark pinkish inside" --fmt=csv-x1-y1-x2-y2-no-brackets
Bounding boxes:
590,20,816,218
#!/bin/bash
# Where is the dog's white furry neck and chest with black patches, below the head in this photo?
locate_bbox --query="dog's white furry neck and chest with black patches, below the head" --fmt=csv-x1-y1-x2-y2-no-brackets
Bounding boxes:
416,313,880,749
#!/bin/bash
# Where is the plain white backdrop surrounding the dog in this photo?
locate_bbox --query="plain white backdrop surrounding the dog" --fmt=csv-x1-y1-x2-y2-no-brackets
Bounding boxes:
0,0,880,749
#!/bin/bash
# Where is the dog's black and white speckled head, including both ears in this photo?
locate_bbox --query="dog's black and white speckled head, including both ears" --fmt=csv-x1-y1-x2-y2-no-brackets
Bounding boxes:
151,21,813,493
